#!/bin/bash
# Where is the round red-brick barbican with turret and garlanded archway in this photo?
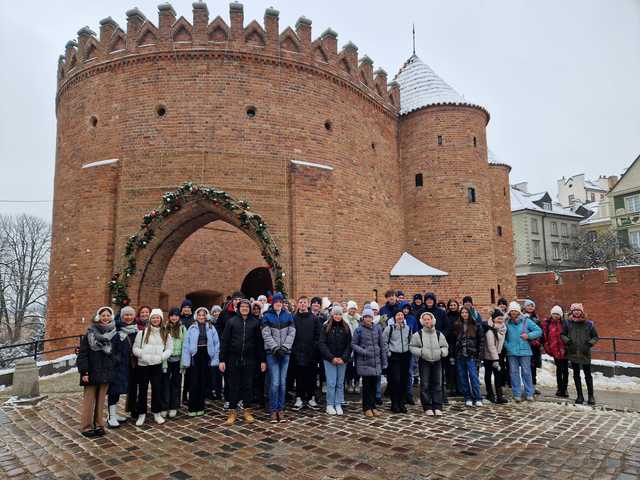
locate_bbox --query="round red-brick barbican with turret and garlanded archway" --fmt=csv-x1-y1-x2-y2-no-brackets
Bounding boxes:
47,2,515,337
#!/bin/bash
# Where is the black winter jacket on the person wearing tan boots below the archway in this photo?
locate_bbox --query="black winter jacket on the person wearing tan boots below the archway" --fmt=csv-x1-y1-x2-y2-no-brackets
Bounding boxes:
220,314,265,365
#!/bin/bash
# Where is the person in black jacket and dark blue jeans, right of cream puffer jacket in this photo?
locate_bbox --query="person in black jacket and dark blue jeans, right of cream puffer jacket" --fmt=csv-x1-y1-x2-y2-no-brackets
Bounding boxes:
454,307,484,407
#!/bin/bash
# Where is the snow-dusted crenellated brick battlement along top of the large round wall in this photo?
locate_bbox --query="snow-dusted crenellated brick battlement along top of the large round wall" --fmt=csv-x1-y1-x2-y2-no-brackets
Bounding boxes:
57,2,400,113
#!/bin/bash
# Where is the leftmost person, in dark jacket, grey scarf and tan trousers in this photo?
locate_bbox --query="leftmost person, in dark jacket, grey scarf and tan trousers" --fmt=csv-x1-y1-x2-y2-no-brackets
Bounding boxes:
76,307,118,438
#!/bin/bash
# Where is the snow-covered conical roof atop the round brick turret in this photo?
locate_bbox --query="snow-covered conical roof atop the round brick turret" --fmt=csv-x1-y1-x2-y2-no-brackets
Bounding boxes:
394,54,478,115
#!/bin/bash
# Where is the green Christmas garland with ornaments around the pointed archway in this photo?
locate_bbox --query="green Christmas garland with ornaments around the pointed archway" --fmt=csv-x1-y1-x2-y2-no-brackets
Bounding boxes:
109,182,286,306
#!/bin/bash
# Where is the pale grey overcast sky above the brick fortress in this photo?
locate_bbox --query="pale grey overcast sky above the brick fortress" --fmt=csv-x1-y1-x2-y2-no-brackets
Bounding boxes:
0,0,640,218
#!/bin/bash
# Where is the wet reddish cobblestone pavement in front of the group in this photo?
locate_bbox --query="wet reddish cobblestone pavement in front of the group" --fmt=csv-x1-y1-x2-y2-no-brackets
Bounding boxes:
0,394,640,480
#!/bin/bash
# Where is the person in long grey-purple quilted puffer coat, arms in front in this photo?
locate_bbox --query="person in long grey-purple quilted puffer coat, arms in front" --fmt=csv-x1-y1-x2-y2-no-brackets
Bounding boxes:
351,308,388,417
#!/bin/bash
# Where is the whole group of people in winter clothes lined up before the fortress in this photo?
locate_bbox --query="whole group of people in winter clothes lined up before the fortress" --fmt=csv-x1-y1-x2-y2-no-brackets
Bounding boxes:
77,290,598,437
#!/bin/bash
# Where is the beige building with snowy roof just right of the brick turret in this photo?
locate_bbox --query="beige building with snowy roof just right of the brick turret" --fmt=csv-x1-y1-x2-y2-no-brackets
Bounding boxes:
511,182,582,274
